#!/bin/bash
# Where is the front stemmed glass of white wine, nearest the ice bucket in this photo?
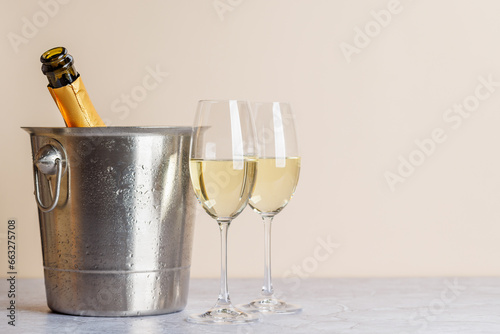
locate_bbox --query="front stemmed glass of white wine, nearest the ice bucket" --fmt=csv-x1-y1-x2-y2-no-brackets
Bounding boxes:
187,100,260,324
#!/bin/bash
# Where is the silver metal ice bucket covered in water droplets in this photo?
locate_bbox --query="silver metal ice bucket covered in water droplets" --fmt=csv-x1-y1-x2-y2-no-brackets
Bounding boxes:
23,127,195,316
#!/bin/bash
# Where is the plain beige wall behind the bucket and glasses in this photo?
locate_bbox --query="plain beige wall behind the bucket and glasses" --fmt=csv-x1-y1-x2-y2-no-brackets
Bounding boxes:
0,0,500,279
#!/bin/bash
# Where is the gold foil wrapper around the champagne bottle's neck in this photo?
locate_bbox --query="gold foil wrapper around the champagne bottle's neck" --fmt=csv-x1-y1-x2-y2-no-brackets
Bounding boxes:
48,77,106,127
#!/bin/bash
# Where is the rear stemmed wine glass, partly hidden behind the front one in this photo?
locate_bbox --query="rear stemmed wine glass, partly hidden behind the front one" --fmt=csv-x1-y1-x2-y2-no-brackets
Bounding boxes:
242,102,302,314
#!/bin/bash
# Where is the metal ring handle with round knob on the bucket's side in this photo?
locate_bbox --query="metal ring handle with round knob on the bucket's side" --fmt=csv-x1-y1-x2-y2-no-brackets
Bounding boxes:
33,142,66,212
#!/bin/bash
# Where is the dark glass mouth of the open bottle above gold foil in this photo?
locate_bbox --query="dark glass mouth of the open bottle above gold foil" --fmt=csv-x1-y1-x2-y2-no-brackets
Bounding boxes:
40,47,80,88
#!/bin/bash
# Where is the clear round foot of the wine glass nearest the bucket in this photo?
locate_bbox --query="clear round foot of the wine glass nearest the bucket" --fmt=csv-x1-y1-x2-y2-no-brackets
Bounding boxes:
186,306,261,325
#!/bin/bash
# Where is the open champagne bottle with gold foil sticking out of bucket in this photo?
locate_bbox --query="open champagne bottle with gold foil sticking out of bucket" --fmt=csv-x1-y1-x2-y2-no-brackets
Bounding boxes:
40,47,106,127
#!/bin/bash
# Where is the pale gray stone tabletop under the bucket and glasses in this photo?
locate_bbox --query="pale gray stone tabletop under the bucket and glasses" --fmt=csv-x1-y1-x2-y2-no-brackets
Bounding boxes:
0,277,500,334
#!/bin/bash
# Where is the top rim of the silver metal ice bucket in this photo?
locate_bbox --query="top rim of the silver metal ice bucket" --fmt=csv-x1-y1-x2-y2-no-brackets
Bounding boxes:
21,126,193,136
